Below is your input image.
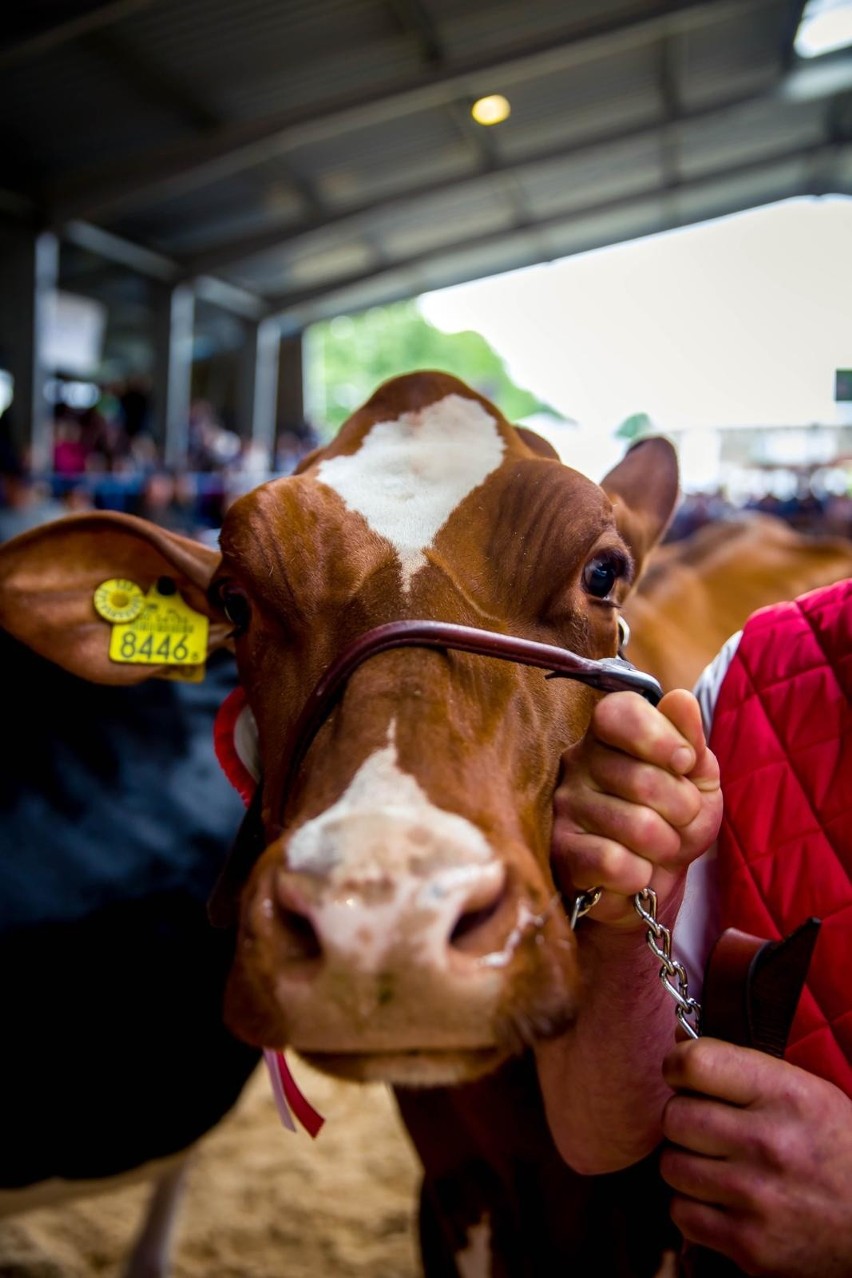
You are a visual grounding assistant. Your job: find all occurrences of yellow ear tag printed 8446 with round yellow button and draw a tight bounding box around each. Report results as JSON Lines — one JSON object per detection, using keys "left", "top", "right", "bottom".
{"left": 95, "top": 576, "right": 208, "bottom": 682}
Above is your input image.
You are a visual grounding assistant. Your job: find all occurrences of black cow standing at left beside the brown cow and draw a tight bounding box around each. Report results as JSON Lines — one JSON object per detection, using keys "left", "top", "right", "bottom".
{"left": 0, "top": 634, "right": 259, "bottom": 1278}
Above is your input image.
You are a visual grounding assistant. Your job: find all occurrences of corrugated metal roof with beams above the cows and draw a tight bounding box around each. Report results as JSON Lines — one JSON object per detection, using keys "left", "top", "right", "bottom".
{"left": 0, "top": 0, "right": 852, "bottom": 368}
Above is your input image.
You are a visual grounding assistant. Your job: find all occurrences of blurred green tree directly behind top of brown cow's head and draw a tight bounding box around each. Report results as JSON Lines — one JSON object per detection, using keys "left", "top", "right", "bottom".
{"left": 305, "top": 300, "right": 557, "bottom": 440}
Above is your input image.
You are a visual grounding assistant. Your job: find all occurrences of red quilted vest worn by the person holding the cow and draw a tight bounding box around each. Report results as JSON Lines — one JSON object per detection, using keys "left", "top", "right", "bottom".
{"left": 710, "top": 580, "right": 852, "bottom": 1095}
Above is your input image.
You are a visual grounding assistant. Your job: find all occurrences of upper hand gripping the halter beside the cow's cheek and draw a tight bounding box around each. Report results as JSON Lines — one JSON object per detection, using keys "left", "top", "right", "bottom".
{"left": 552, "top": 689, "right": 722, "bottom": 928}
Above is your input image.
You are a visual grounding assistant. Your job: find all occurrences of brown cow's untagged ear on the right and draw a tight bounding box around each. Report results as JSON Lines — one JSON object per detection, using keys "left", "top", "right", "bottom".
{"left": 600, "top": 436, "right": 678, "bottom": 571}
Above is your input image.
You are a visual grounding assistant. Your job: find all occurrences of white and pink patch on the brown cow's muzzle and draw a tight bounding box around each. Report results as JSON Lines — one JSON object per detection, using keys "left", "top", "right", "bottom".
{"left": 287, "top": 728, "right": 503, "bottom": 970}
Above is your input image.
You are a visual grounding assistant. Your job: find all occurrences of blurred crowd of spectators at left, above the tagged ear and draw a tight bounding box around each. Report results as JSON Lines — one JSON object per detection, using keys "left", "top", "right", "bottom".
{"left": 0, "top": 381, "right": 323, "bottom": 541}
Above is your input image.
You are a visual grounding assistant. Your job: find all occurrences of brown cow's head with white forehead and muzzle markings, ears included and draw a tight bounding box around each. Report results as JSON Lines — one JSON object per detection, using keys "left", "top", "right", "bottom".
{"left": 0, "top": 373, "right": 677, "bottom": 1084}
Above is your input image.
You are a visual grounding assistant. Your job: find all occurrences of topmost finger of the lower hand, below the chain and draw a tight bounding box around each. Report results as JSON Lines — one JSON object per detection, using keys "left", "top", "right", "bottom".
{"left": 663, "top": 1038, "right": 778, "bottom": 1108}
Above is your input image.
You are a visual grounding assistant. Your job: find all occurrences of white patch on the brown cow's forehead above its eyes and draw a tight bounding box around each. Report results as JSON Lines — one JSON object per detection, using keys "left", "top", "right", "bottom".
{"left": 317, "top": 395, "right": 506, "bottom": 590}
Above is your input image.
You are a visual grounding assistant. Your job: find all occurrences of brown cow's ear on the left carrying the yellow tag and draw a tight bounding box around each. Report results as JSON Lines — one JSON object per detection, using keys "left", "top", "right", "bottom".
{"left": 0, "top": 512, "right": 231, "bottom": 684}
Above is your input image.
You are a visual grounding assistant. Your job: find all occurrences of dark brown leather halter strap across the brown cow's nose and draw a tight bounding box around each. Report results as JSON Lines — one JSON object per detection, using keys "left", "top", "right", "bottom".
{"left": 208, "top": 620, "right": 663, "bottom": 927}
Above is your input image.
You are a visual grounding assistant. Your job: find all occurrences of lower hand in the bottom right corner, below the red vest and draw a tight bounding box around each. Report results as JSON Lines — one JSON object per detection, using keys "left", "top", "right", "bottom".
{"left": 660, "top": 1038, "right": 852, "bottom": 1278}
